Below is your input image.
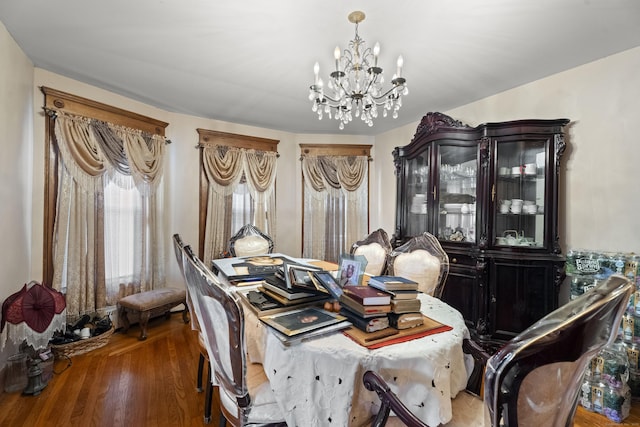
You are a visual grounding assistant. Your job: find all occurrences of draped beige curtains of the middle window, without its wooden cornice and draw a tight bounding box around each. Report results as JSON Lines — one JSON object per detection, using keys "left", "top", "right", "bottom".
{"left": 202, "top": 145, "right": 278, "bottom": 262}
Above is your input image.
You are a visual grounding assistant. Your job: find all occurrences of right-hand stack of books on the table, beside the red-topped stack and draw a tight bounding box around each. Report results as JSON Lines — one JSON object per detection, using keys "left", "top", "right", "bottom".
{"left": 369, "top": 276, "right": 423, "bottom": 329}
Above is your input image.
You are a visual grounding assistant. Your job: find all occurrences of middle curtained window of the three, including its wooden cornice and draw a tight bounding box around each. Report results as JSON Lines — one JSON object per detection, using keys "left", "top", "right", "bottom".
{"left": 198, "top": 129, "right": 278, "bottom": 260}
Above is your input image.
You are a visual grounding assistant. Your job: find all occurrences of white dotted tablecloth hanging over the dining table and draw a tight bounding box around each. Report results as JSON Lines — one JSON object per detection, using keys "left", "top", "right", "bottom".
{"left": 245, "top": 295, "right": 470, "bottom": 427}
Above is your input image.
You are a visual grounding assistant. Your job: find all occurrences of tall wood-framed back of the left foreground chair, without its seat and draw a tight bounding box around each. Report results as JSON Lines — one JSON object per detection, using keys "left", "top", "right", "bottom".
{"left": 184, "top": 246, "right": 251, "bottom": 424}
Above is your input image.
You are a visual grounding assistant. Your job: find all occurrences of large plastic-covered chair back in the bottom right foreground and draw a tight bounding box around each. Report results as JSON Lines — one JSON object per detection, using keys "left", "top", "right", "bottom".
{"left": 484, "top": 275, "right": 634, "bottom": 427}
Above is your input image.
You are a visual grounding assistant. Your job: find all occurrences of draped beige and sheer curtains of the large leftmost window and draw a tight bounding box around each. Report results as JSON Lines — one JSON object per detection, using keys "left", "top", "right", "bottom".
{"left": 52, "top": 111, "right": 166, "bottom": 318}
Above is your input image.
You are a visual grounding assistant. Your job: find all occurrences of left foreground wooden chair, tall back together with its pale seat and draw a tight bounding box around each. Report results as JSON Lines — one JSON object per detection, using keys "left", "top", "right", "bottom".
{"left": 179, "top": 248, "right": 285, "bottom": 426}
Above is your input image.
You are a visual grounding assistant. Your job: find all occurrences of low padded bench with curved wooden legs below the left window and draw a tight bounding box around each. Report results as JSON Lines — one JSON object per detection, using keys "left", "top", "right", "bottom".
{"left": 118, "top": 288, "right": 189, "bottom": 341}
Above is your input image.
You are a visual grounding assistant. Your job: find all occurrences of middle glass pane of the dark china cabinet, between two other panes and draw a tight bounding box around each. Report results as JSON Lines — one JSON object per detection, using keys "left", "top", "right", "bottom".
{"left": 436, "top": 143, "right": 478, "bottom": 243}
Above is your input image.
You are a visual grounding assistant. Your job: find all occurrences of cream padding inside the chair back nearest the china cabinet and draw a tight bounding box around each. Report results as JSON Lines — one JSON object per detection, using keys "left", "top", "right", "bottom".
{"left": 393, "top": 249, "right": 440, "bottom": 295}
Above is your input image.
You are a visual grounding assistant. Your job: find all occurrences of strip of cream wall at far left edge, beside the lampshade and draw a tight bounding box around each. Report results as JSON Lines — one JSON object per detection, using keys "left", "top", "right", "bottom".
{"left": 0, "top": 19, "right": 34, "bottom": 366}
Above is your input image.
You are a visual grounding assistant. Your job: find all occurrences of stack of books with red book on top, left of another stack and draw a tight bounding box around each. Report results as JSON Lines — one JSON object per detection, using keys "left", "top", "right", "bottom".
{"left": 339, "top": 285, "right": 391, "bottom": 332}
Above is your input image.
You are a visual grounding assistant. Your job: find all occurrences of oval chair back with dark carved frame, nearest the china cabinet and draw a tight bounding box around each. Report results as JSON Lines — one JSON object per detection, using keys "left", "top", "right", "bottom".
{"left": 388, "top": 232, "right": 449, "bottom": 298}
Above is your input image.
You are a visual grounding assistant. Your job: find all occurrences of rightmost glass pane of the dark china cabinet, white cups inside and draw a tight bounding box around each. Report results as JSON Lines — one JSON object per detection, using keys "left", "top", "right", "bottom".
{"left": 493, "top": 140, "right": 546, "bottom": 248}
